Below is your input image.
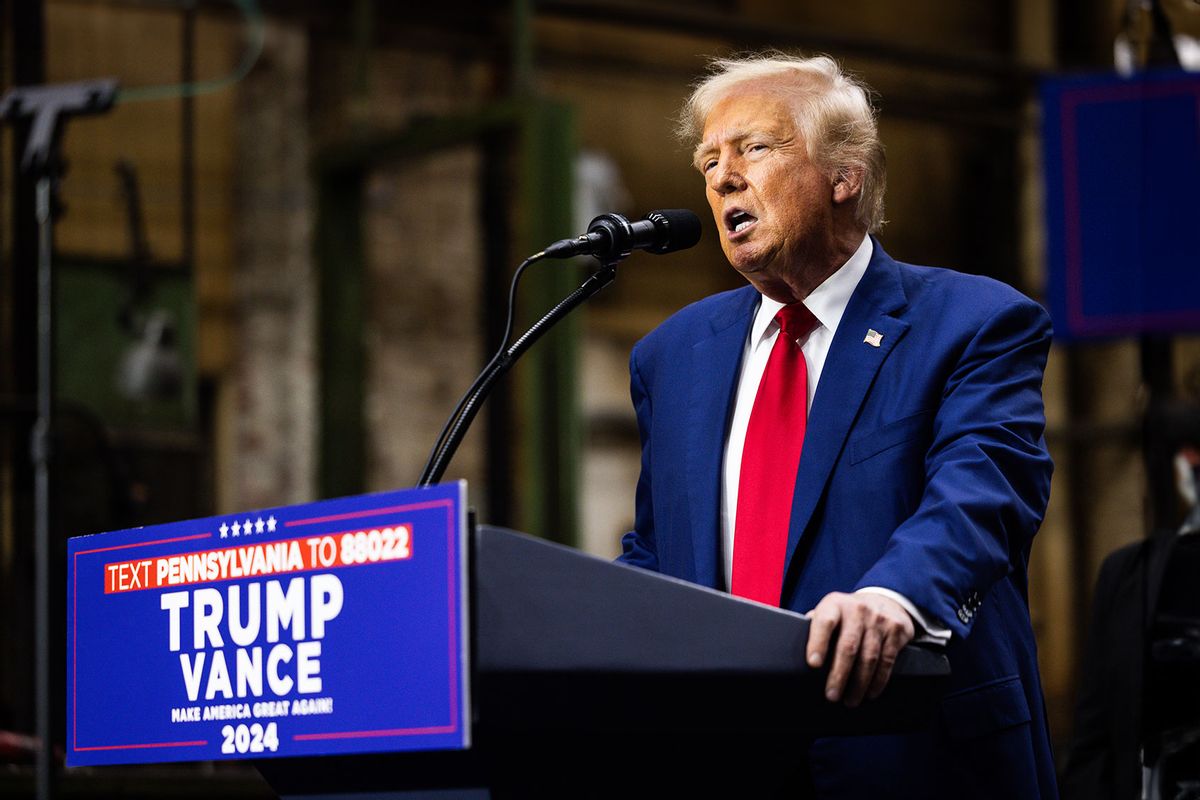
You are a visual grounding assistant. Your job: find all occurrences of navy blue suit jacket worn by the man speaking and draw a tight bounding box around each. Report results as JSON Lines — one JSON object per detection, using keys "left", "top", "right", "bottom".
{"left": 620, "top": 242, "right": 1056, "bottom": 798}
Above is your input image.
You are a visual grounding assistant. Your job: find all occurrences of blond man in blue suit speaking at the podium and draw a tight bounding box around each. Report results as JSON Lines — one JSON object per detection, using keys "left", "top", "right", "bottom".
{"left": 620, "top": 54, "right": 1056, "bottom": 799}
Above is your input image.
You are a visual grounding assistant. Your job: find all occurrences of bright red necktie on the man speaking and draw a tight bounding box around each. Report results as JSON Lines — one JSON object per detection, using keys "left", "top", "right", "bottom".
{"left": 731, "top": 302, "right": 817, "bottom": 606}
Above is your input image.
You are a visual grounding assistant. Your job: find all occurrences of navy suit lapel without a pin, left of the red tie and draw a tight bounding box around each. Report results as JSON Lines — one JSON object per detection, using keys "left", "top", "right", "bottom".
{"left": 686, "top": 287, "right": 758, "bottom": 588}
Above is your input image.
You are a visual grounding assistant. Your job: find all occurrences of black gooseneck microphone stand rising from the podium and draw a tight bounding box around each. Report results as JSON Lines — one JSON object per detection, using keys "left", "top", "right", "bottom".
{"left": 416, "top": 260, "right": 629, "bottom": 486}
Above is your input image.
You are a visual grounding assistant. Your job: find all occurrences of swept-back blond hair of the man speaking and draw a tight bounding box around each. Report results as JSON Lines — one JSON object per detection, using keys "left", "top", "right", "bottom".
{"left": 677, "top": 52, "right": 887, "bottom": 233}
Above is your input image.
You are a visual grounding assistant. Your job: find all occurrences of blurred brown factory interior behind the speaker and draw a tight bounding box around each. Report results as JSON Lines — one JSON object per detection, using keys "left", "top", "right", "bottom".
{"left": 0, "top": 0, "right": 1200, "bottom": 796}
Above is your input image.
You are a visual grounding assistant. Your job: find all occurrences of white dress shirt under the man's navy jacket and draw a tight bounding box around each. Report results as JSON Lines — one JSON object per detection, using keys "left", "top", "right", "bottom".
{"left": 721, "top": 236, "right": 950, "bottom": 642}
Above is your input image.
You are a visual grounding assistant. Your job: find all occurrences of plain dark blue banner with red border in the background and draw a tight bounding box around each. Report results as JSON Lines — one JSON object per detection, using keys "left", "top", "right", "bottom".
{"left": 1042, "top": 72, "right": 1200, "bottom": 338}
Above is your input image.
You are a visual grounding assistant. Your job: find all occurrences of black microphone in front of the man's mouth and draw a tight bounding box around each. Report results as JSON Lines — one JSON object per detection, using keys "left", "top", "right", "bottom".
{"left": 541, "top": 209, "right": 700, "bottom": 263}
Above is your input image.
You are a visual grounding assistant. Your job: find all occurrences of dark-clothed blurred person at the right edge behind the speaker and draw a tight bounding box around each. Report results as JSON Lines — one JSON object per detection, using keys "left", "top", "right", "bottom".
{"left": 1062, "top": 403, "right": 1200, "bottom": 800}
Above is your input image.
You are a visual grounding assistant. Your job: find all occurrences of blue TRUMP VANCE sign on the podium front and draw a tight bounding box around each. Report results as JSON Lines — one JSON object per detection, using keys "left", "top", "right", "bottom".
{"left": 67, "top": 481, "right": 470, "bottom": 766}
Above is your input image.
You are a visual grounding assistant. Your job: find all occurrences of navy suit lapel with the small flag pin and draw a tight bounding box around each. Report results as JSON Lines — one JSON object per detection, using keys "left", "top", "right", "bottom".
{"left": 784, "top": 241, "right": 910, "bottom": 584}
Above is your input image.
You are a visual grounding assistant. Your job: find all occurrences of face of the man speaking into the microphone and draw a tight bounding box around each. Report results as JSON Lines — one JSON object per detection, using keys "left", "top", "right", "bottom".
{"left": 695, "top": 85, "right": 840, "bottom": 302}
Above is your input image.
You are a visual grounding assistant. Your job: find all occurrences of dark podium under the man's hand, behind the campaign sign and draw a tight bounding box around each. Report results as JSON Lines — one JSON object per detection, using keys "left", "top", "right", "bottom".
{"left": 257, "top": 525, "right": 949, "bottom": 800}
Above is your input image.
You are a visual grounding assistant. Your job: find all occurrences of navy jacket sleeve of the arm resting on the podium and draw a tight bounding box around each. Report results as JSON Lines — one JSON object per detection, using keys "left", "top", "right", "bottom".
{"left": 857, "top": 297, "right": 1052, "bottom": 636}
